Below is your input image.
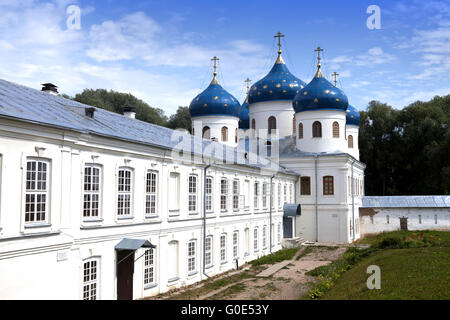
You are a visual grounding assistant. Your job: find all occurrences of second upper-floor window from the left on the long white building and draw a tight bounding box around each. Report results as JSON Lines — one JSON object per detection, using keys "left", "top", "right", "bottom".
{"left": 83, "top": 164, "right": 100, "bottom": 218}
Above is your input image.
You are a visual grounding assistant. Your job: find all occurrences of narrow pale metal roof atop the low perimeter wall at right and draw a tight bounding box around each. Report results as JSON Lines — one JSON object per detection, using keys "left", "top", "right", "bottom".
{"left": 362, "top": 196, "right": 450, "bottom": 208}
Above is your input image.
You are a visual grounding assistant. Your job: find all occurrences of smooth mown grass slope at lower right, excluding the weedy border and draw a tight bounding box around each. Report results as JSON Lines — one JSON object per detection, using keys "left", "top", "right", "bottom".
{"left": 322, "top": 247, "right": 450, "bottom": 300}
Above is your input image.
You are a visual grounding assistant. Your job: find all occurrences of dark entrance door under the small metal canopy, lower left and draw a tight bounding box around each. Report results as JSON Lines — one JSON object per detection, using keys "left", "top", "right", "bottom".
{"left": 116, "top": 250, "right": 134, "bottom": 300}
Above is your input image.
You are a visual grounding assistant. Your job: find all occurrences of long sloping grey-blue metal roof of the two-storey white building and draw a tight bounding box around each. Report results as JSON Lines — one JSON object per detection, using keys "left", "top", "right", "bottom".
{"left": 0, "top": 79, "right": 296, "bottom": 175}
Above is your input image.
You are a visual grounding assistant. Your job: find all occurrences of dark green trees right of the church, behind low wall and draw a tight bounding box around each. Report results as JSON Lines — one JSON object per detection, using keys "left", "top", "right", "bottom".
{"left": 359, "top": 95, "right": 450, "bottom": 195}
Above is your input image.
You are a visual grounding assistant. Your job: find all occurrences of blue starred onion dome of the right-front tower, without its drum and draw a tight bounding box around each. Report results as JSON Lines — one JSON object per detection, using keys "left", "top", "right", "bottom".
{"left": 292, "top": 67, "right": 348, "bottom": 112}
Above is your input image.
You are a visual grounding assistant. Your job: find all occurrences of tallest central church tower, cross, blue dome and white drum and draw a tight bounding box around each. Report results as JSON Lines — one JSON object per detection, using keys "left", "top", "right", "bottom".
{"left": 248, "top": 32, "right": 306, "bottom": 137}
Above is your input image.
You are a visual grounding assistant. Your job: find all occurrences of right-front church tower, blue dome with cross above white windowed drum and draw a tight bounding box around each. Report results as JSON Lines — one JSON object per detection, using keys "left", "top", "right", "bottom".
{"left": 292, "top": 47, "right": 348, "bottom": 153}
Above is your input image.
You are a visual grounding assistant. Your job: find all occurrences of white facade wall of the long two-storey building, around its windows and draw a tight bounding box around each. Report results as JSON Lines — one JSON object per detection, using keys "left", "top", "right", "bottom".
{"left": 0, "top": 120, "right": 296, "bottom": 299}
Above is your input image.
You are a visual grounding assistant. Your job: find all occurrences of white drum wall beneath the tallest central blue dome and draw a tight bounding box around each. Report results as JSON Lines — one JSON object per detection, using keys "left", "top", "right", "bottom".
{"left": 248, "top": 100, "right": 294, "bottom": 137}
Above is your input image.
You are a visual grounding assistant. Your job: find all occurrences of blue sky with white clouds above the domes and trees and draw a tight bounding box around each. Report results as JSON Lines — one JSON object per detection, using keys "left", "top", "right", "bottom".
{"left": 0, "top": 0, "right": 450, "bottom": 115}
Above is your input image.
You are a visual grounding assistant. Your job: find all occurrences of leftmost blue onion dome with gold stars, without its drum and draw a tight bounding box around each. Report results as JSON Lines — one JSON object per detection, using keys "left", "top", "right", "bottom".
{"left": 189, "top": 77, "right": 241, "bottom": 118}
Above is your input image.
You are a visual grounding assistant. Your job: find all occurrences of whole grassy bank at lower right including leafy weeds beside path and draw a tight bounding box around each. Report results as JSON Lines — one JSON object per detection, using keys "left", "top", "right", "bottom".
{"left": 303, "top": 231, "right": 450, "bottom": 300}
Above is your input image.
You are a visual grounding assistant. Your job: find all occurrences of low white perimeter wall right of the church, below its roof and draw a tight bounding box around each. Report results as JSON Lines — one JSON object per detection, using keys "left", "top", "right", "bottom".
{"left": 359, "top": 208, "right": 450, "bottom": 235}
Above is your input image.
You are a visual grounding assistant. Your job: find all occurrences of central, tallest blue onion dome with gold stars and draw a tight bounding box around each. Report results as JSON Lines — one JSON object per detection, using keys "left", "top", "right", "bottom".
{"left": 248, "top": 55, "right": 306, "bottom": 103}
